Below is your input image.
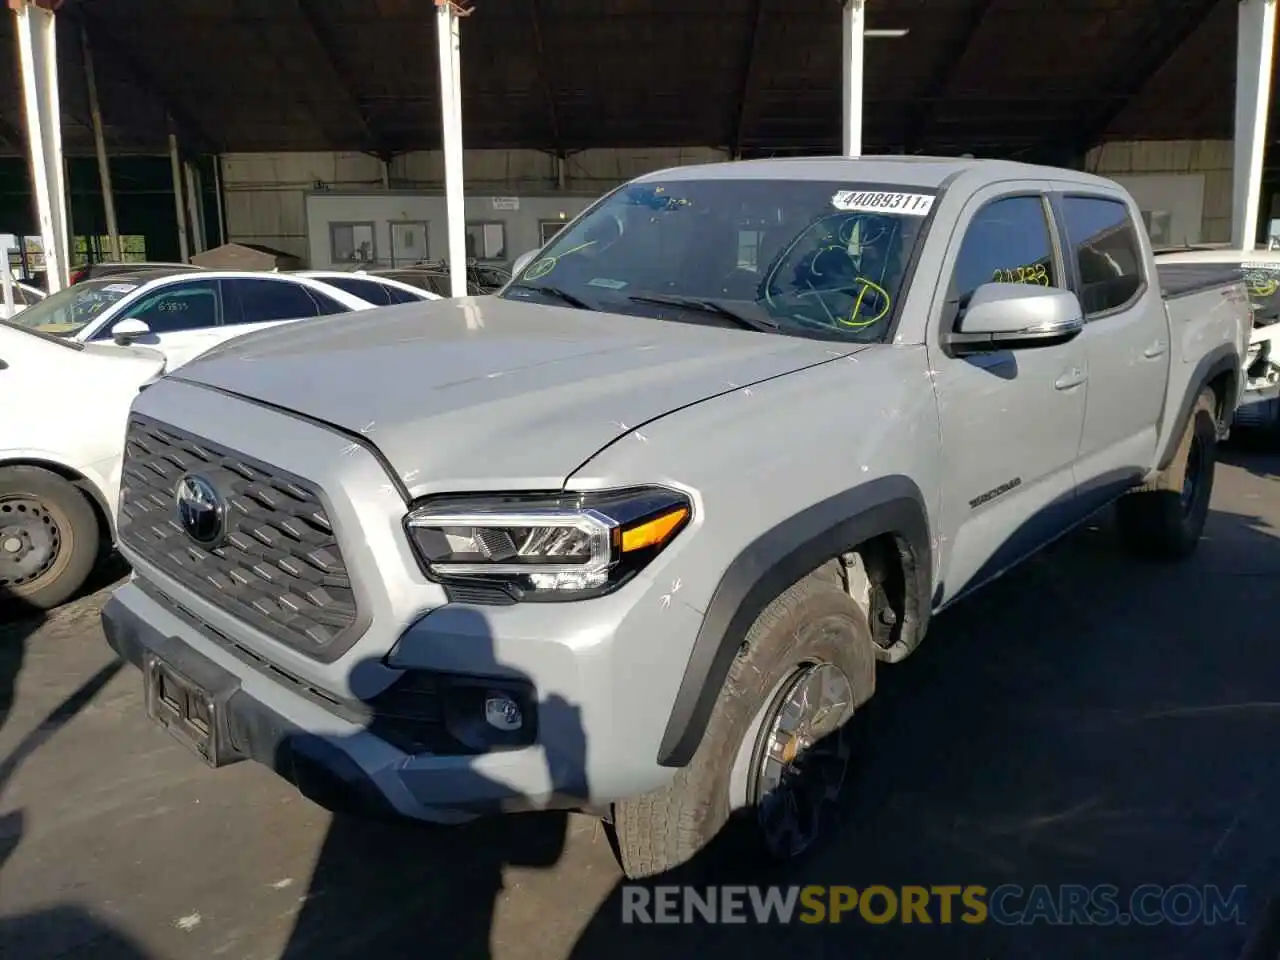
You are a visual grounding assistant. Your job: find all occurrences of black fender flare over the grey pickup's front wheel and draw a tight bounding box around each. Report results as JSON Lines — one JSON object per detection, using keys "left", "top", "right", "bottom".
{"left": 658, "top": 475, "right": 933, "bottom": 767}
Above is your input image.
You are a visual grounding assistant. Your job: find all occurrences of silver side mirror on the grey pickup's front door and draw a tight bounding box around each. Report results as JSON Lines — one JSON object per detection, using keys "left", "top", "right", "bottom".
{"left": 947, "top": 283, "right": 1084, "bottom": 351}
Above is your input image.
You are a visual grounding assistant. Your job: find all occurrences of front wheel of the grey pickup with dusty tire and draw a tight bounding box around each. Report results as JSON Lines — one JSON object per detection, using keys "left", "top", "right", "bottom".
{"left": 613, "top": 575, "right": 876, "bottom": 879}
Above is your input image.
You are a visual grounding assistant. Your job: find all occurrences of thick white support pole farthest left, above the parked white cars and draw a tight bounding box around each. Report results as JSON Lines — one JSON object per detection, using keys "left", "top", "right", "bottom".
{"left": 9, "top": 0, "right": 70, "bottom": 293}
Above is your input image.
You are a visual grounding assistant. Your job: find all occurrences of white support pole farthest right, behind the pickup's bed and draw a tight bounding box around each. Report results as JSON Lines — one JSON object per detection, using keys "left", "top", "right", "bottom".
{"left": 1231, "top": 0, "right": 1276, "bottom": 250}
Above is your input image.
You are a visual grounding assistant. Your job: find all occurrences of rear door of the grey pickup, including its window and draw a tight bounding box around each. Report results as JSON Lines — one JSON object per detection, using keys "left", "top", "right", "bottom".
{"left": 1053, "top": 186, "right": 1170, "bottom": 508}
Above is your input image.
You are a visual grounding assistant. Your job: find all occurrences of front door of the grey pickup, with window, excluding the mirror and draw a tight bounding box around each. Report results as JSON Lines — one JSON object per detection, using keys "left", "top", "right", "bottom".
{"left": 929, "top": 182, "right": 1088, "bottom": 603}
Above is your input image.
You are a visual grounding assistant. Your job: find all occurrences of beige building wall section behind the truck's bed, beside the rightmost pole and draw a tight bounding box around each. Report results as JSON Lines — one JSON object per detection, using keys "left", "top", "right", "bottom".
{"left": 1085, "top": 140, "right": 1233, "bottom": 243}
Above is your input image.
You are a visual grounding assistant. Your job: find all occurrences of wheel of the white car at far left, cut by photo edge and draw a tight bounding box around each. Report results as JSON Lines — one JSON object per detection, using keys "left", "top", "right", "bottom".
{"left": 0, "top": 467, "right": 101, "bottom": 609}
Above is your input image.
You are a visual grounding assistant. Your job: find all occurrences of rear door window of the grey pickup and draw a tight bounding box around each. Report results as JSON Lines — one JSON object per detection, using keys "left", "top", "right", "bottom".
{"left": 1062, "top": 197, "right": 1142, "bottom": 317}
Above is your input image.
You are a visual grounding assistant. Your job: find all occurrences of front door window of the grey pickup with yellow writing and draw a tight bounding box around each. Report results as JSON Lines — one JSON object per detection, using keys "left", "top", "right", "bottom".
{"left": 951, "top": 197, "right": 1061, "bottom": 307}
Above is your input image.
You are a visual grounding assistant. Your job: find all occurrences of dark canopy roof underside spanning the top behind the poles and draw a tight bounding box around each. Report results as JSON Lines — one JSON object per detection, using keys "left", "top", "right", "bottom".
{"left": 0, "top": 0, "right": 1236, "bottom": 155}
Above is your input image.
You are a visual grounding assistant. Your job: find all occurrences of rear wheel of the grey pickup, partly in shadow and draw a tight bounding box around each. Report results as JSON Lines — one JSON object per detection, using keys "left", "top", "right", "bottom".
{"left": 1116, "top": 390, "right": 1217, "bottom": 561}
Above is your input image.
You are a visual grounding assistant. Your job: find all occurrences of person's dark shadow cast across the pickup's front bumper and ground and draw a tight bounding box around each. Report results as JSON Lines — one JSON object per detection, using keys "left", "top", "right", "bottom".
{"left": 267, "top": 609, "right": 589, "bottom": 960}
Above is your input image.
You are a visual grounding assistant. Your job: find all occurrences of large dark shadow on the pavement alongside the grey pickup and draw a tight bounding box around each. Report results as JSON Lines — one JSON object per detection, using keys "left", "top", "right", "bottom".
{"left": 573, "top": 512, "right": 1280, "bottom": 960}
